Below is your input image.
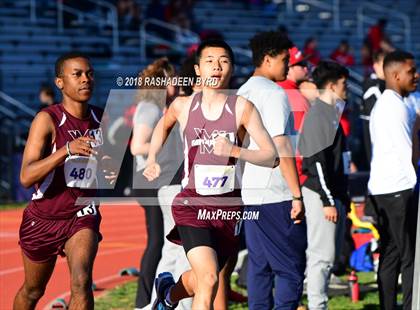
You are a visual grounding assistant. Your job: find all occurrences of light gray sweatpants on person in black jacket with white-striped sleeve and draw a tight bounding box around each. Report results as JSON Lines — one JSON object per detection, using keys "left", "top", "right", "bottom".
{"left": 302, "top": 187, "right": 346, "bottom": 310}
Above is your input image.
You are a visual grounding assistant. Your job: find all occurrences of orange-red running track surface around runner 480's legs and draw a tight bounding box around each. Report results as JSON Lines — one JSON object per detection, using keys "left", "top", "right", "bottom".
{"left": 0, "top": 202, "right": 147, "bottom": 310}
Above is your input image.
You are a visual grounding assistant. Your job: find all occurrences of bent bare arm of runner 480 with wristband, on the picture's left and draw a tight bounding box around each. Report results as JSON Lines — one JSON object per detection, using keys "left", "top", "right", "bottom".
{"left": 20, "top": 112, "right": 95, "bottom": 188}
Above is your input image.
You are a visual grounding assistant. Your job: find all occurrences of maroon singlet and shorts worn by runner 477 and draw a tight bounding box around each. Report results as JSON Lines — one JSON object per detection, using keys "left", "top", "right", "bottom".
{"left": 168, "top": 92, "right": 243, "bottom": 236}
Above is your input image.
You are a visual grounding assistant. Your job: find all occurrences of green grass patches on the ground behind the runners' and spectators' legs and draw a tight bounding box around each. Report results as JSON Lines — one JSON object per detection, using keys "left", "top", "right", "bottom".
{"left": 95, "top": 272, "right": 401, "bottom": 310}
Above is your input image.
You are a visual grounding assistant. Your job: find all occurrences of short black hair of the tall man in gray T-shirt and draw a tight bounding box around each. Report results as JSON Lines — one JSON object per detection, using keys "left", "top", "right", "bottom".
{"left": 249, "top": 31, "right": 293, "bottom": 67}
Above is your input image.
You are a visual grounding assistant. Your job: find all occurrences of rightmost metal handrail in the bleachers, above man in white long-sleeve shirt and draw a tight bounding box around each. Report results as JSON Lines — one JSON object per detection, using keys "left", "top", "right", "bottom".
{"left": 357, "top": 2, "right": 411, "bottom": 50}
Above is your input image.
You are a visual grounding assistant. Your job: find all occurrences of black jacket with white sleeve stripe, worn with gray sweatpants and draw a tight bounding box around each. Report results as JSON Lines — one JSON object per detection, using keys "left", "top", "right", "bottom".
{"left": 298, "top": 99, "right": 350, "bottom": 206}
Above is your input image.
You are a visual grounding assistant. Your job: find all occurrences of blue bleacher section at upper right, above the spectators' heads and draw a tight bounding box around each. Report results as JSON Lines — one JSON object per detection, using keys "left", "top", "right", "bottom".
{"left": 194, "top": 0, "right": 420, "bottom": 71}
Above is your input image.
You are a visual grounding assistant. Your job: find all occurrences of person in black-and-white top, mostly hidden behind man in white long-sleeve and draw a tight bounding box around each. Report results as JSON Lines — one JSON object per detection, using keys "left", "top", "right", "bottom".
{"left": 360, "top": 50, "right": 386, "bottom": 167}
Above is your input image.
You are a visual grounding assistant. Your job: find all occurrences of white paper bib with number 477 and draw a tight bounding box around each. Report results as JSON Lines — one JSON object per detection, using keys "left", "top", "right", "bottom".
{"left": 194, "top": 165, "right": 235, "bottom": 196}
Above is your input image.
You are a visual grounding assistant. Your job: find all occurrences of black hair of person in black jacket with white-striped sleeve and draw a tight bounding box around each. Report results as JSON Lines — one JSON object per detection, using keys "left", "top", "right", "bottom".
{"left": 312, "top": 61, "right": 349, "bottom": 89}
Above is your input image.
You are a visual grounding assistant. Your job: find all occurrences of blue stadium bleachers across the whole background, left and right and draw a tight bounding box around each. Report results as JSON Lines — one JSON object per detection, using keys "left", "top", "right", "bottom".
{"left": 0, "top": 0, "right": 420, "bottom": 198}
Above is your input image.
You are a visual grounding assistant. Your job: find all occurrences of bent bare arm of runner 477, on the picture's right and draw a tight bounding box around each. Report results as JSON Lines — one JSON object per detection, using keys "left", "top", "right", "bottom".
{"left": 215, "top": 97, "right": 279, "bottom": 168}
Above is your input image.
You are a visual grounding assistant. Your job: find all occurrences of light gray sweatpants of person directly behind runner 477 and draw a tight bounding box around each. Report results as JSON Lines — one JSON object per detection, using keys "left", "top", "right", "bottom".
{"left": 143, "top": 185, "right": 192, "bottom": 310}
